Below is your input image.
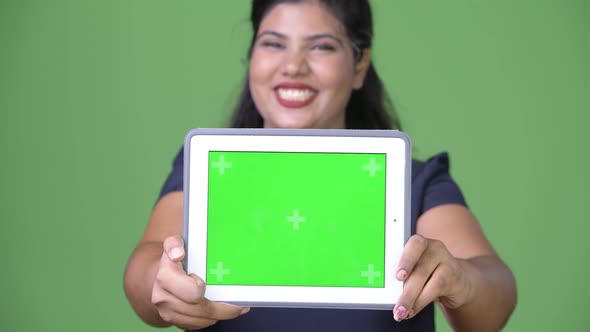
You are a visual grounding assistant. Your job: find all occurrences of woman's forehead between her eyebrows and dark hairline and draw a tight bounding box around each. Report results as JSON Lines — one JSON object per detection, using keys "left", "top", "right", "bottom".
{"left": 257, "top": 1, "right": 346, "bottom": 36}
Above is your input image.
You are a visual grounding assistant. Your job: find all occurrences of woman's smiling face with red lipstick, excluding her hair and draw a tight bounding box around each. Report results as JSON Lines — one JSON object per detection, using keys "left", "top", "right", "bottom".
{"left": 249, "top": 3, "right": 370, "bottom": 128}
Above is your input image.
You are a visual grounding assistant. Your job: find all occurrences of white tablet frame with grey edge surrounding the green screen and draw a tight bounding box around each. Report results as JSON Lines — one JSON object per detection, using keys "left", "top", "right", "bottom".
{"left": 183, "top": 129, "right": 411, "bottom": 309}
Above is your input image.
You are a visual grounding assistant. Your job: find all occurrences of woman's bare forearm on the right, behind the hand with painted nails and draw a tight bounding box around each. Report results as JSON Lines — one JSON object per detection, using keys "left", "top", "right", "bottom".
{"left": 441, "top": 256, "right": 516, "bottom": 331}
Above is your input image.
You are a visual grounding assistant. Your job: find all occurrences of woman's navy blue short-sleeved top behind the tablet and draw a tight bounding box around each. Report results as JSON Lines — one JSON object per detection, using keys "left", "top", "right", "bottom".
{"left": 160, "top": 149, "right": 466, "bottom": 332}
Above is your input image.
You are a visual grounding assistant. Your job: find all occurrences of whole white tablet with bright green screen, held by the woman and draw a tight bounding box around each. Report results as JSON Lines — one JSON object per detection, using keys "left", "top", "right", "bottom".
{"left": 184, "top": 129, "right": 411, "bottom": 309}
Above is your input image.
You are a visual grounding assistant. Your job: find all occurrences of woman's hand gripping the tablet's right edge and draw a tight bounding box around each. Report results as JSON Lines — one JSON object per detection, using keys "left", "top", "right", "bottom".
{"left": 393, "top": 235, "right": 471, "bottom": 322}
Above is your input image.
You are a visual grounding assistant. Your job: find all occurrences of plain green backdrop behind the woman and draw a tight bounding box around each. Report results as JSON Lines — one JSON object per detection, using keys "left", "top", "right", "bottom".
{"left": 0, "top": 0, "right": 590, "bottom": 331}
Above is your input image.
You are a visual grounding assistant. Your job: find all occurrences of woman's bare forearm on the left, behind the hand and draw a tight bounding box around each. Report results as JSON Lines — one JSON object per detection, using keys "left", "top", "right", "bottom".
{"left": 124, "top": 241, "right": 170, "bottom": 327}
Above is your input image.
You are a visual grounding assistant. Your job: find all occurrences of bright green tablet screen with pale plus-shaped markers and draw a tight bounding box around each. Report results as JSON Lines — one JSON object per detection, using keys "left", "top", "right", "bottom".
{"left": 206, "top": 151, "right": 386, "bottom": 287}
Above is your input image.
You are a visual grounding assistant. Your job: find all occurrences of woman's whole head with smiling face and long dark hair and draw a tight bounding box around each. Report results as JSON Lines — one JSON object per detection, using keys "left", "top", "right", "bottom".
{"left": 231, "top": 0, "right": 400, "bottom": 129}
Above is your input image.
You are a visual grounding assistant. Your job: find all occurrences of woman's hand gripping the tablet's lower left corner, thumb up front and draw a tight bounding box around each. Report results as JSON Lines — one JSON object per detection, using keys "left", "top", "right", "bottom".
{"left": 152, "top": 236, "right": 250, "bottom": 330}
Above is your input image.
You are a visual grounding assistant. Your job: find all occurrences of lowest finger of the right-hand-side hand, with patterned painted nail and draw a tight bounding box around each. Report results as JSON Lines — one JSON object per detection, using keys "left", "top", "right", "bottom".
{"left": 393, "top": 257, "right": 438, "bottom": 322}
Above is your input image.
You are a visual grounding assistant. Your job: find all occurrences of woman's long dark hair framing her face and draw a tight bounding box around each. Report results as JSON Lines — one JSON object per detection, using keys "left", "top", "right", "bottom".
{"left": 230, "top": 0, "right": 401, "bottom": 129}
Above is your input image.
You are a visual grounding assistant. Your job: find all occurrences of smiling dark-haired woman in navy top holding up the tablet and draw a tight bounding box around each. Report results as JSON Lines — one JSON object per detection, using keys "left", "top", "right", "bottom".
{"left": 125, "top": 0, "right": 516, "bottom": 331}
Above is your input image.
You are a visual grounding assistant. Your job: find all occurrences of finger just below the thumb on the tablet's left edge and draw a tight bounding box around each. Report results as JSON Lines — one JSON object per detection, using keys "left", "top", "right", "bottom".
{"left": 152, "top": 260, "right": 205, "bottom": 303}
